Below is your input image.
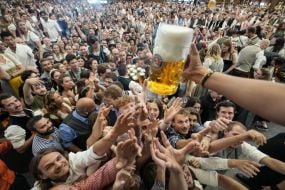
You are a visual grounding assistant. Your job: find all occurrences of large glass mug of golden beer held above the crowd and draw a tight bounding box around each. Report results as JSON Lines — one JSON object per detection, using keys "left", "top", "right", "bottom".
{"left": 148, "top": 23, "right": 193, "bottom": 95}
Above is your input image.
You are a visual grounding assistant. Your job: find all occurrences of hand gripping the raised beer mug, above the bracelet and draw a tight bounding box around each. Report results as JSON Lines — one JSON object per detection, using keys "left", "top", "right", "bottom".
{"left": 182, "top": 43, "right": 208, "bottom": 83}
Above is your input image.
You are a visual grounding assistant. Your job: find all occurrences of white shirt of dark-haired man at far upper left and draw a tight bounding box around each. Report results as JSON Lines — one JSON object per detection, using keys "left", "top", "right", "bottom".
{"left": 5, "top": 44, "right": 37, "bottom": 68}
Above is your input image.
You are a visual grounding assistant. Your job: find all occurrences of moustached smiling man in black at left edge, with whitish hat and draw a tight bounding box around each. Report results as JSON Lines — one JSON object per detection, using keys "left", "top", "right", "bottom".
{"left": 0, "top": 93, "right": 34, "bottom": 173}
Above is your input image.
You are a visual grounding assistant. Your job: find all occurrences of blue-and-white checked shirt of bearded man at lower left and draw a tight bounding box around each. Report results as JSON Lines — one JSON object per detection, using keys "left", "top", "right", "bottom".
{"left": 32, "top": 128, "right": 63, "bottom": 156}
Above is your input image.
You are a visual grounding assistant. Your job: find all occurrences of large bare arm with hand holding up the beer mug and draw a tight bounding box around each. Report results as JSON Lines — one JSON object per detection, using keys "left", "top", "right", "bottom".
{"left": 183, "top": 44, "right": 285, "bottom": 124}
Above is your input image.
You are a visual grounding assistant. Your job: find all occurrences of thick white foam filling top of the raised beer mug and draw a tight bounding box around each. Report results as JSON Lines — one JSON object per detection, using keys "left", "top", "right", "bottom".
{"left": 153, "top": 23, "right": 193, "bottom": 61}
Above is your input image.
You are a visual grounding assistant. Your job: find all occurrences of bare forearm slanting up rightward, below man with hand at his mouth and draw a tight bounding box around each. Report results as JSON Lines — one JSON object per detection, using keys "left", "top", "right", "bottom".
{"left": 206, "top": 134, "right": 247, "bottom": 153}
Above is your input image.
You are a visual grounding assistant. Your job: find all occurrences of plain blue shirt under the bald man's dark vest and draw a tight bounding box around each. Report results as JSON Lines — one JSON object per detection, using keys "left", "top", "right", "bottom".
{"left": 59, "top": 110, "right": 89, "bottom": 148}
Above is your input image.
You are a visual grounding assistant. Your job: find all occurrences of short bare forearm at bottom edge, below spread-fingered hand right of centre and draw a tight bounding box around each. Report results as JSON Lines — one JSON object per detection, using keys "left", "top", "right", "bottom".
{"left": 169, "top": 168, "right": 188, "bottom": 190}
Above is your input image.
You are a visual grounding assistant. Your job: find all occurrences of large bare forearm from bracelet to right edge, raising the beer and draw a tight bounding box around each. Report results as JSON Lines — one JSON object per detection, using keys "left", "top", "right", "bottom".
{"left": 205, "top": 73, "right": 285, "bottom": 124}
